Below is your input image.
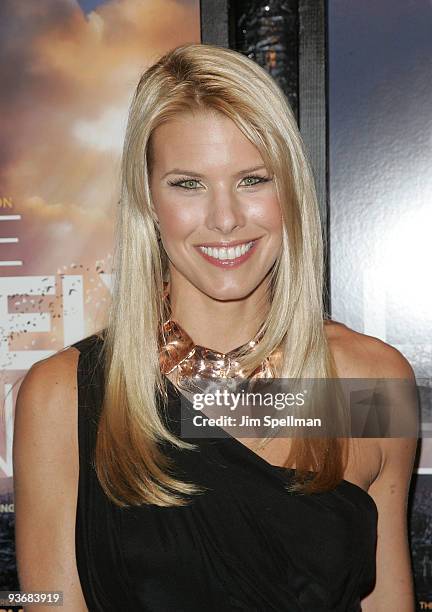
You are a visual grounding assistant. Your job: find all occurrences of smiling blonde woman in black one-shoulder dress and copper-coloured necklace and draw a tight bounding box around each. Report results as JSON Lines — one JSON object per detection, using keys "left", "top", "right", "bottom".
{"left": 14, "top": 44, "right": 416, "bottom": 612}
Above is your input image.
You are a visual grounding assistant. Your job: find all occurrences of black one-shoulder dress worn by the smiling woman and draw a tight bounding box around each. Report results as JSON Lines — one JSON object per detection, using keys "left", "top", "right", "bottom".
{"left": 73, "top": 335, "right": 378, "bottom": 612}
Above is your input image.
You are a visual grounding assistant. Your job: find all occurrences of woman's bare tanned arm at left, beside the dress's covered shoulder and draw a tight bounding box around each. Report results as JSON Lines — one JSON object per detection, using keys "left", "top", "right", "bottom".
{"left": 13, "top": 348, "right": 87, "bottom": 612}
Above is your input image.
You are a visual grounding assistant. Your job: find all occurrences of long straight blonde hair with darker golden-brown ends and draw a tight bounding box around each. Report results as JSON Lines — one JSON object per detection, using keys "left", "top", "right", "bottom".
{"left": 95, "top": 44, "right": 344, "bottom": 506}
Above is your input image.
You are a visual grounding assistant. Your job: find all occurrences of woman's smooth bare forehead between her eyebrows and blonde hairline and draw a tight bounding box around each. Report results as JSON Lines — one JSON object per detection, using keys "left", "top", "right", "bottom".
{"left": 151, "top": 111, "right": 262, "bottom": 171}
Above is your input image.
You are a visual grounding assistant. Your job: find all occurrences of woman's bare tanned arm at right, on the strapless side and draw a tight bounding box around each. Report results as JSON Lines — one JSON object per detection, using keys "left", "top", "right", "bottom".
{"left": 362, "top": 343, "right": 417, "bottom": 612}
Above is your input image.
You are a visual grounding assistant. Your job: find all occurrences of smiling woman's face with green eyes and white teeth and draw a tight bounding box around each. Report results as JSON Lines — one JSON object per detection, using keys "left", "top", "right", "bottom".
{"left": 150, "top": 112, "right": 282, "bottom": 300}
